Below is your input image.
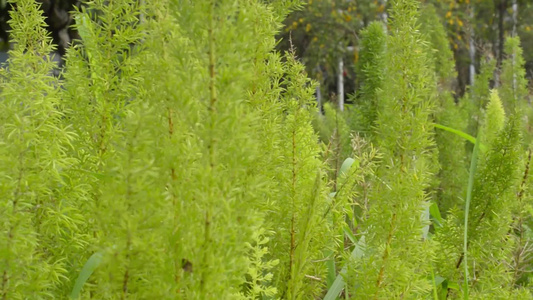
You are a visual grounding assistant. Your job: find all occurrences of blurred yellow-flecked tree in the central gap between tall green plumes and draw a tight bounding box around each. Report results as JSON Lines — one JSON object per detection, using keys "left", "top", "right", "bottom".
{"left": 278, "top": 0, "right": 378, "bottom": 103}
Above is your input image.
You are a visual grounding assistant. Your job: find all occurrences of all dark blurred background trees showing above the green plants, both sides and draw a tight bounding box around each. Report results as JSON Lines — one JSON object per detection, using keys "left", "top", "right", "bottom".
{"left": 0, "top": 0, "right": 533, "bottom": 106}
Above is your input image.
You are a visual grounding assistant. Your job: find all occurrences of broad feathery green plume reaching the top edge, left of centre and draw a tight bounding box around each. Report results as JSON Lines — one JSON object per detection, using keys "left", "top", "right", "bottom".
{"left": 134, "top": 1, "right": 290, "bottom": 299}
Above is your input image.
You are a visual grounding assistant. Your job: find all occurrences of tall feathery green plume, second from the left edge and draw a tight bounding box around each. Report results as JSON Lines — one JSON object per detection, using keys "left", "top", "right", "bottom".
{"left": 64, "top": 1, "right": 159, "bottom": 298}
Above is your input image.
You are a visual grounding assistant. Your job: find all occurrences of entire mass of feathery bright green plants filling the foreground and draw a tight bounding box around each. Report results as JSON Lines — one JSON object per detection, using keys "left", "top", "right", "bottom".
{"left": 0, "top": 0, "right": 533, "bottom": 300}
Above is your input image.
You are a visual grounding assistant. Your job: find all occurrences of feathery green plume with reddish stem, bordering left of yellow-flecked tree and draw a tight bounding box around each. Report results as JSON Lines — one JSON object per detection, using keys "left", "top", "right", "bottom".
{"left": 231, "top": 3, "right": 330, "bottom": 299}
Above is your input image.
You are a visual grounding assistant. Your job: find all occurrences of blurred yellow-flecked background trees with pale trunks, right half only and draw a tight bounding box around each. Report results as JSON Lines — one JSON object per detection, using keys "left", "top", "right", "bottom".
{"left": 278, "top": 0, "right": 533, "bottom": 106}
